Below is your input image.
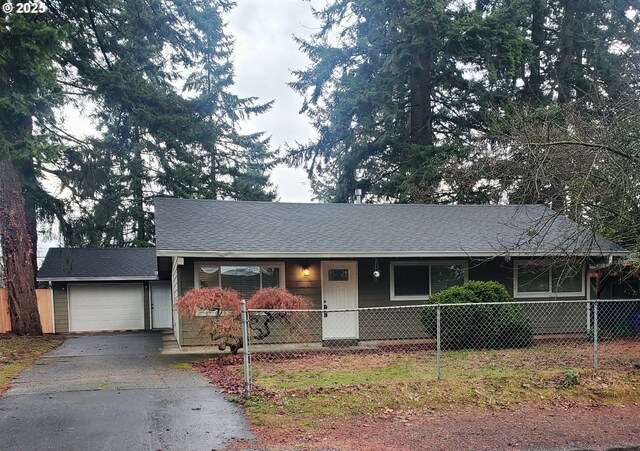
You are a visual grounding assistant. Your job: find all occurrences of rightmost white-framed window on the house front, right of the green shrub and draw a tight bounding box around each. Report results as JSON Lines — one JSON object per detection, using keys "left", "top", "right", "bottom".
{"left": 514, "top": 262, "right": 585, "bottom": 297}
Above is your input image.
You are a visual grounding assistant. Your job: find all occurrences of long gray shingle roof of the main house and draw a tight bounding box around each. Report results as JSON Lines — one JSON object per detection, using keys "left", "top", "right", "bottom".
{"left": 155, "top": 198, "right": 624, "bottom": 257}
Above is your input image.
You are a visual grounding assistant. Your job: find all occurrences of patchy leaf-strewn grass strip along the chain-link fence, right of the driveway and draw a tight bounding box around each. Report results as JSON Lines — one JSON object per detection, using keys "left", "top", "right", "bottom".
{"left": 198, "top": 341, "right": 640, "bottom": 428}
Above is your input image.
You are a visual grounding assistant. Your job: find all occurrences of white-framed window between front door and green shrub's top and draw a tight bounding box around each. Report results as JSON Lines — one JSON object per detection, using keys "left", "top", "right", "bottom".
{"left": 390, "top": 261, "right": 467, "bottom": 301}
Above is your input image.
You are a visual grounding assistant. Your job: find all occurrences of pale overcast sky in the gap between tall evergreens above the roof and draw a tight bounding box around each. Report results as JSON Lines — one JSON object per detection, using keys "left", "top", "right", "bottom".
{"left": 227, "top": 0, "right": 324, "bottom": 202}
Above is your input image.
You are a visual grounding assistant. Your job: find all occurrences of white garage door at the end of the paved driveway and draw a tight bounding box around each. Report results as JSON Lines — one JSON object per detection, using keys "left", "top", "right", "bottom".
{"left": 69, "top": 283, "right": 144, "bottom": 332}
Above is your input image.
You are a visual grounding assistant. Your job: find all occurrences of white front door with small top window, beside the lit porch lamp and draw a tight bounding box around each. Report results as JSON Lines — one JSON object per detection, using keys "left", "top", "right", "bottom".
{"left": 321, "top": 261, "right": 358, "bottom": 340}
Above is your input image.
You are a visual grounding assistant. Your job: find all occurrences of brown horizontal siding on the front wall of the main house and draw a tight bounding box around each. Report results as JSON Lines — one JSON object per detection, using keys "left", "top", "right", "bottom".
{"left": 174, "top": 258, "right": 587, "bottom": 346}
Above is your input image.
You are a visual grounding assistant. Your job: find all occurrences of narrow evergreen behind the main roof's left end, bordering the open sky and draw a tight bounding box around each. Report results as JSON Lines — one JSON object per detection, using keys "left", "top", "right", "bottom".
{"left": 184, "top": 4, "right": 275, "bottom": 200}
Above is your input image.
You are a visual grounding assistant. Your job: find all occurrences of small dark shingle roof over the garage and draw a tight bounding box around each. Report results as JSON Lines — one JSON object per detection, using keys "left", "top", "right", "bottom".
{"left": 38, "top": 247, "right": 158, "bottom": 280}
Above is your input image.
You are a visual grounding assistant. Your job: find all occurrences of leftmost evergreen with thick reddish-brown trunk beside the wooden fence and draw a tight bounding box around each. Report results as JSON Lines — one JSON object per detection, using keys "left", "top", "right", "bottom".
{"left": 0, "top": 13, "right": 63, "bottom": 334}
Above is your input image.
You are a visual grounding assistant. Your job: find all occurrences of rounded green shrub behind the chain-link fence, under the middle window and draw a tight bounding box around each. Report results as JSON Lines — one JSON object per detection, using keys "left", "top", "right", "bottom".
{"left": 421, "top": 281, "right": 533, "bottom": 349}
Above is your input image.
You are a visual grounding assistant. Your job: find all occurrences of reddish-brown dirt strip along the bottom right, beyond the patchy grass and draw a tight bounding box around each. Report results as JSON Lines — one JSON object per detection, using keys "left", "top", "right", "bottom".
{"left": 231, "top": 405, "right": 640, "bottom": 451}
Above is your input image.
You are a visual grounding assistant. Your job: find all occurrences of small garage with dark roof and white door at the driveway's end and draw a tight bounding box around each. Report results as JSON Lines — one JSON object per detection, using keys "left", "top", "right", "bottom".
{"left": 38, "top": 248, "right": 172, "bottom": 333}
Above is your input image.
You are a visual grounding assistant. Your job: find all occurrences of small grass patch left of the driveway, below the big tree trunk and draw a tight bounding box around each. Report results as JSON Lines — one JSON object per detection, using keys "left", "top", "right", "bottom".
{"left": 0, "top": 334, "right": 64, "bottom": 396}
